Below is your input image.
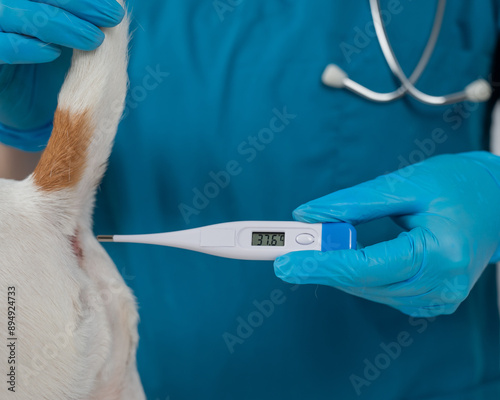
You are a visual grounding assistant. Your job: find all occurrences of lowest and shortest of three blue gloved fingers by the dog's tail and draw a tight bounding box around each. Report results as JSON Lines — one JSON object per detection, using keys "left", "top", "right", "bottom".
{"left": 0, "top": 32, "right": 61, "bottom": 64}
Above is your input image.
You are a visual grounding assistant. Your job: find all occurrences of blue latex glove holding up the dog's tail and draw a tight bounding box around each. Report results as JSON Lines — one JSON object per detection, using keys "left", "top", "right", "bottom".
{"left": 0, "top": 0, "right": 124, "bottom": 151}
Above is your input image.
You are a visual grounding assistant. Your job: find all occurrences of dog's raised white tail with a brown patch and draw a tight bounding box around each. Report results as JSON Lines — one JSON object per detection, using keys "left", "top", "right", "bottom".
{"left": 33, "top": 0, "right": 129, "bottom": 227}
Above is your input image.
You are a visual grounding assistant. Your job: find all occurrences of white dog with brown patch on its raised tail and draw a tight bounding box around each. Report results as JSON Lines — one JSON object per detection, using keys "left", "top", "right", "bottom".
{"left": 0, "top": 1, "right": 145, "bottom": 400}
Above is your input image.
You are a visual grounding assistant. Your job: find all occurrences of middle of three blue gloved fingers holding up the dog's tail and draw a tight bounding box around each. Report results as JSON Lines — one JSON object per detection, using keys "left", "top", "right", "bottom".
{"left": 0, "top": 0, "right": 104, "bottom": 51}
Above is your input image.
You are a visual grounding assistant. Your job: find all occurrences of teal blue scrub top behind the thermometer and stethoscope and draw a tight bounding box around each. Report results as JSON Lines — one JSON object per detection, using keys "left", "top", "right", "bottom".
{"left": 95, "top": 0, "right": 500, "bottom": 400}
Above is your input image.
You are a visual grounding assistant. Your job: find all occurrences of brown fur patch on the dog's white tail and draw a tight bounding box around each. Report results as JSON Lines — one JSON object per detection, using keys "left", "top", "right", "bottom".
{"left": 33, "top": 109, "right": 94, "bottom": 191}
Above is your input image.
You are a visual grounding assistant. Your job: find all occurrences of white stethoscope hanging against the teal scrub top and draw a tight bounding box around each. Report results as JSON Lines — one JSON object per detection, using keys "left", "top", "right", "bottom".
{"left": 322, "top": 0, "right": 492, "bottom": 106}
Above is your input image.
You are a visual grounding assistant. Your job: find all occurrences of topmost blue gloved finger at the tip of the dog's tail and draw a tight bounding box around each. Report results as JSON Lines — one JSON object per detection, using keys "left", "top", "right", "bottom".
{"left": 31, "top": 0, "right": 125, "bottom": 28}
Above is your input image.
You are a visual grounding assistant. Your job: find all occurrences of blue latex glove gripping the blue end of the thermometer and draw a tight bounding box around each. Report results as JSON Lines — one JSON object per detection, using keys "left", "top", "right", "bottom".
{"left": 274, "top": 152, "right": 500, "bottom": 317}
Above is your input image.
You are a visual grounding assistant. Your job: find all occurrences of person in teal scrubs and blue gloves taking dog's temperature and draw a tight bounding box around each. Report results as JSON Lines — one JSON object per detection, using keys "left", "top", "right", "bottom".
{"left": 0, "top": 0, "right": 500, "bottom": 400}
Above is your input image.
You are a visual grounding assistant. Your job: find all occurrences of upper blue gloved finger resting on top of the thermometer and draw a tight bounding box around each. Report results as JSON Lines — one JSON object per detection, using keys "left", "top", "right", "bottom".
{"left": 293, "top": 174, "right": 420, "bottom": 225}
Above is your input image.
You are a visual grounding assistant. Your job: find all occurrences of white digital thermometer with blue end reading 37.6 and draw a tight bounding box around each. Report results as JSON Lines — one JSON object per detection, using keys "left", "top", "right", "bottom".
{"left": 97, "top": 221, "right": 356, "bottom": 260}
